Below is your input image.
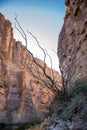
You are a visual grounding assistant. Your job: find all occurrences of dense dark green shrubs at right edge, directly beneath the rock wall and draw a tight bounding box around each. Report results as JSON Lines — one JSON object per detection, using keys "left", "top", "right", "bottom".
{"left": 59, "top": 79, "right": 87, "bottom": 120}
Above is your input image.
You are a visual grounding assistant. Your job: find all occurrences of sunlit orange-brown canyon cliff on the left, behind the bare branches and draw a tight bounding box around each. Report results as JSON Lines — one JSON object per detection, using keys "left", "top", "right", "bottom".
{"left": 0, "top": 14, "right": 59, "bottom": 124}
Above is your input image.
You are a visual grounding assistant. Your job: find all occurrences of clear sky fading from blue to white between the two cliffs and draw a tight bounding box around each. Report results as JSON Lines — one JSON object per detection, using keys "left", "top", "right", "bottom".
{"left": 0, "top": 0, "right": 65, "bottom": 70}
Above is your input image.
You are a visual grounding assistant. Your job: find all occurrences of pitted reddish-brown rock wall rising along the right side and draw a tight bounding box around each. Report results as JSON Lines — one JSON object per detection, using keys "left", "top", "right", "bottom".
{"left": 58, "top": 0, "right": 87, "bottom": 89}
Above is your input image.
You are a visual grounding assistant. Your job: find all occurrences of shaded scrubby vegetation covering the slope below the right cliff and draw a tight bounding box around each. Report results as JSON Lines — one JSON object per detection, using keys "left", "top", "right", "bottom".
{"left": 14, "top": 79, "right": 87, "bottom": 130}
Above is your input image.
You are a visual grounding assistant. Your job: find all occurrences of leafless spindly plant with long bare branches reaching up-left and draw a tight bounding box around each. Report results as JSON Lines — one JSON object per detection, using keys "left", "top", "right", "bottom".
{"left": 15, "top": 15, "right": 68, "bottom": 98}
